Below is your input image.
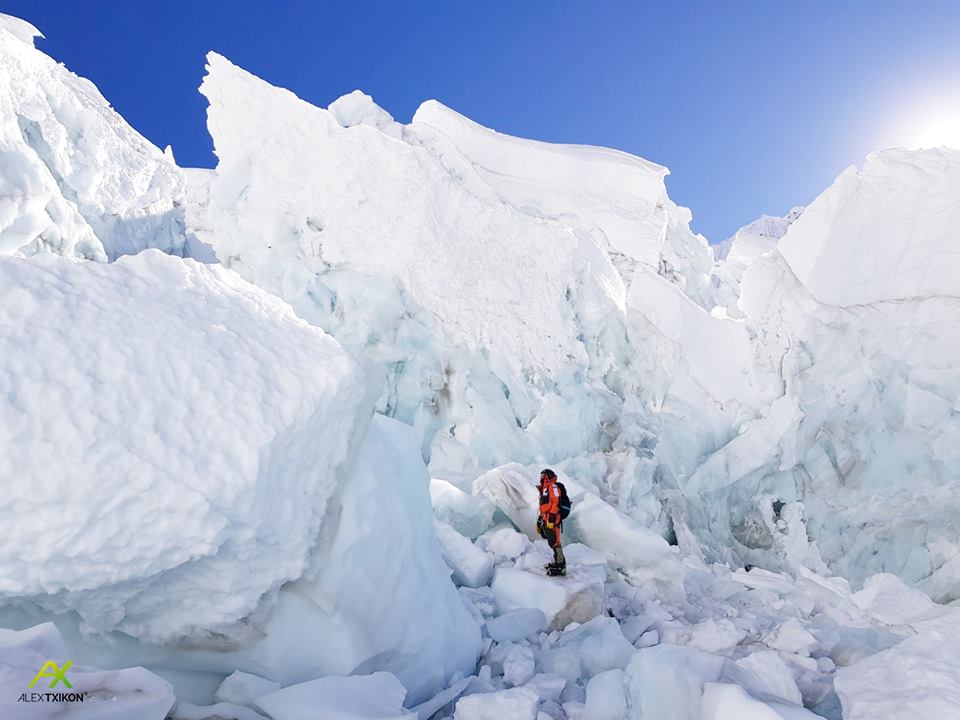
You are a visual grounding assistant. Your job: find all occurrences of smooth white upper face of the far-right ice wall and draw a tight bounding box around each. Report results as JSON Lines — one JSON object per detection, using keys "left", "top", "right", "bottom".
{"left": 778, "top": 148, "right": 960, "bottom": 307}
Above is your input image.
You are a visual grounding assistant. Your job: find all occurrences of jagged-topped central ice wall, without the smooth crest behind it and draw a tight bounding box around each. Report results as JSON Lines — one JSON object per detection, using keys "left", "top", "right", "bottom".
{"left": 192, "top": 54, "right": 648, "bottom": 480}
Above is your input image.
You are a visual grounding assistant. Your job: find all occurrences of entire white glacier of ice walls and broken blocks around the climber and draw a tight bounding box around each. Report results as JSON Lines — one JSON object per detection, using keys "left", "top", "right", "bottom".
{"left": 0, "top": 15, "right": 960, "bottom": 720}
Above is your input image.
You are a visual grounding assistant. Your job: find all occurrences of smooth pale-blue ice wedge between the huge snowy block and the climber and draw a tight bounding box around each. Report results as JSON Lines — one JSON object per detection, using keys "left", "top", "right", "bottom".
{"left": 219, "top": 415, "right": 480, "bottom": 703}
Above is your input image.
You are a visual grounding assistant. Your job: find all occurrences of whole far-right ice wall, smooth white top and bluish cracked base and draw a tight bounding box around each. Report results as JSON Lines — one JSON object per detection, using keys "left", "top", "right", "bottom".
{"left": 688, "top": 149, "right": 960, "bottom": 600}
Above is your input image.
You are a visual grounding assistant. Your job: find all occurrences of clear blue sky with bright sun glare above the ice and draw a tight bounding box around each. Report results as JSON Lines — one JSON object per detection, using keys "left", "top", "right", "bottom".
{"left": 9, "top": 0, "right": 960, "bottom": 242}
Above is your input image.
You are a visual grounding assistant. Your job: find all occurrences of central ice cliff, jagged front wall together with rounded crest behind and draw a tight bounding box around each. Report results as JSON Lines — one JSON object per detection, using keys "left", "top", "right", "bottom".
{"left": 197, "top": 54, "right": 736, "bottom": 500}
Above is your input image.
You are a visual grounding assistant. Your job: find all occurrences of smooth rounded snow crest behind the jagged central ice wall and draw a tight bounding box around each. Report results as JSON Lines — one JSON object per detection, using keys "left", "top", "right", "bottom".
{"left": 408, "top": 100, "right": 709, "bottom": 299}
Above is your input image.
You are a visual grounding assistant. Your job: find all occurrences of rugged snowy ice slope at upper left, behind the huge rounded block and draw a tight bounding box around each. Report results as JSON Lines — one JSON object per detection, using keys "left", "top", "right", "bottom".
{"left": 0, "top": 16, "right": 186, "bottom": 259}
